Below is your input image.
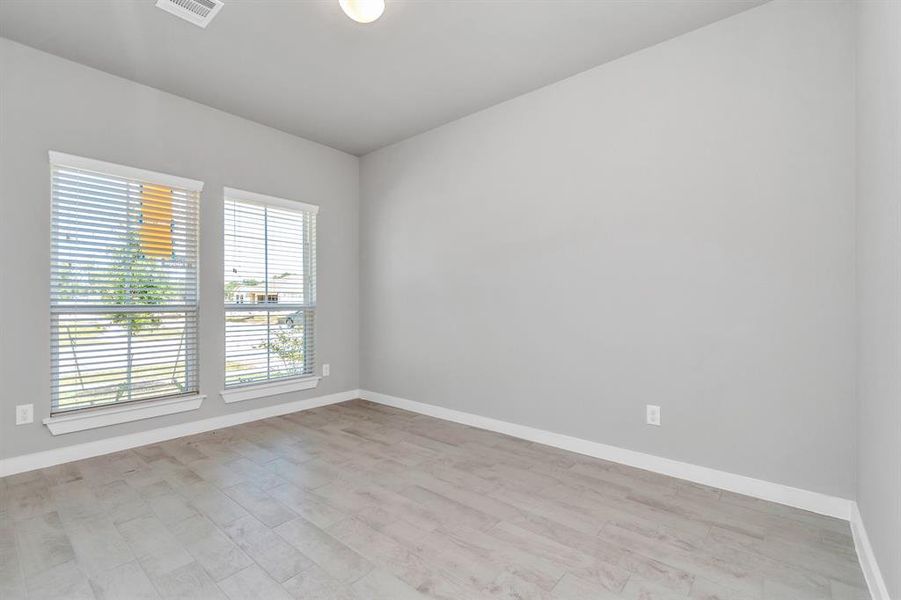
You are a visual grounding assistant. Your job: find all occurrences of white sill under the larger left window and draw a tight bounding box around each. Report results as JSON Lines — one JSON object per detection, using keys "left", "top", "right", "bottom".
{"left": 44, "top": 394, "right": 206, "bottom": 435}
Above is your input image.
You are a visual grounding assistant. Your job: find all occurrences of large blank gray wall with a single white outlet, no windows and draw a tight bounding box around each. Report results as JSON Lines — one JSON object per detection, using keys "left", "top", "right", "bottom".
{"left": 361, "top": 1, "right": 857, "bottom": 498}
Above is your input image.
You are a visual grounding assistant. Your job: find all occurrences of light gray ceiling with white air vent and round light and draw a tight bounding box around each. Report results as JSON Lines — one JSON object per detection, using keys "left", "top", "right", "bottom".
{"left": 0, "top": 0, "right": 766, "bottom": 155}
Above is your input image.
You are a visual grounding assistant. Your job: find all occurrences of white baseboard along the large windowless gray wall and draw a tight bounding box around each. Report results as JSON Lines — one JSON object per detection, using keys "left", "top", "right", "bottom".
{"left": 360, "top": 390, "right": 854, "bottom": 521}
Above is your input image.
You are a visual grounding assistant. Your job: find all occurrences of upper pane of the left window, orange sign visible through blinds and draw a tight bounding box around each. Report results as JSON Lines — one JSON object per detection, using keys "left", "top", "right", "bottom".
{"left": 51, "top": 168, "right": 197, "bottom": 305}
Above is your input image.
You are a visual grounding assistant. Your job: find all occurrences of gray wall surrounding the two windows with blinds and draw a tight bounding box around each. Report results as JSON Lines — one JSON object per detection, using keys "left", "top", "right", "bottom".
{"left": 0, "top": 39, "right": 359, "bottom": 458}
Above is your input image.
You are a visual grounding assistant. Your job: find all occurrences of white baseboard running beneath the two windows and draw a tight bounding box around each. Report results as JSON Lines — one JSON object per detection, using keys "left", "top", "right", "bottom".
{"left": 0, "top": 390, "right": 361, "bottom": 477}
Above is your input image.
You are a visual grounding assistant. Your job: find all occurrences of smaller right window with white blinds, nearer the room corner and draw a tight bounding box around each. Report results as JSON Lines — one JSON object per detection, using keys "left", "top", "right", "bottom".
{"left": 225, "top": 188, "right": 318, "bottom": 388}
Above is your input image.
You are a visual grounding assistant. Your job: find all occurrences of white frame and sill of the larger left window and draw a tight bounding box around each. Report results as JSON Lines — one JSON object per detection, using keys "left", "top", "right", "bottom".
{"left": 43, "top": 151, "right": 205, "bottom": 435}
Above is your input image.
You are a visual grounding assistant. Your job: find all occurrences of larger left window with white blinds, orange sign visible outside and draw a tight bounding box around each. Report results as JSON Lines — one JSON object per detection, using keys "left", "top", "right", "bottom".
{"left": 50, "top": 152, "right": 202, "bottom": 413}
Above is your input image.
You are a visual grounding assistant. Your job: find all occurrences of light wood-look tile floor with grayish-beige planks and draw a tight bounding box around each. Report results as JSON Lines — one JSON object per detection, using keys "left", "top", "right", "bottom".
{"left": 0, "top": 400, "right": 868, "bottom": 600}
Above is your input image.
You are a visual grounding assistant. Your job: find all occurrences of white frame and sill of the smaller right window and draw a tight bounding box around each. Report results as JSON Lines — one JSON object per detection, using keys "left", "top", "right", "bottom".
{"left": 220, "top": 187, "right": 321, "bottom": 403}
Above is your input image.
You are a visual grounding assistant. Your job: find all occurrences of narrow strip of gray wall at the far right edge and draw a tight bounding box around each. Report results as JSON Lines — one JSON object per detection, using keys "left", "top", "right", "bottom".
{"left": 857, "top": 0, "right": 901, "bottom": 598}
